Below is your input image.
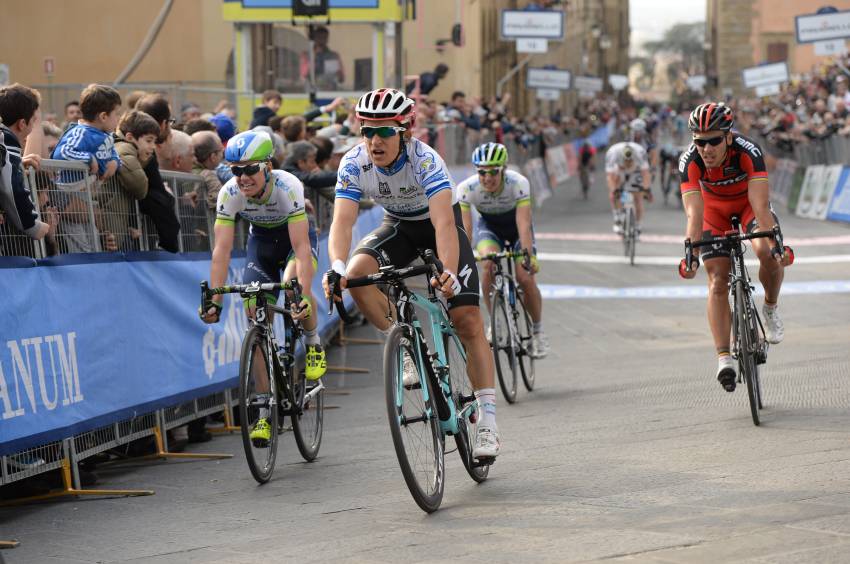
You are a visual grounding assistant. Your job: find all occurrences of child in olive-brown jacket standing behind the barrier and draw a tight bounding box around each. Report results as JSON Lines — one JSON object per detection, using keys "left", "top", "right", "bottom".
{"left": 98, "top": 110, "right": 160, "bottom": 251}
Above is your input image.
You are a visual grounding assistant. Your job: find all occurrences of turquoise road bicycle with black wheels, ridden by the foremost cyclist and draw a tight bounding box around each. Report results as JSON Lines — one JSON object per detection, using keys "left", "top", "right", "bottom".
{"left": 328, "top": 250, "right": 495, "bottom": 513}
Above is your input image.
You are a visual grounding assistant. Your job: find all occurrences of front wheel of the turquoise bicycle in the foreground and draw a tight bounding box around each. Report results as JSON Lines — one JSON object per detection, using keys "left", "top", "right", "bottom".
{"left": 384, "top": 326, "right": 445, "bottom": 513}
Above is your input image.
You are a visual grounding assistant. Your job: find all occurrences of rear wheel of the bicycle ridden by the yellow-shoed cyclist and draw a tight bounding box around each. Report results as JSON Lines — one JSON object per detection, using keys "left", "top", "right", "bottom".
{"left": 289, "top": 338, "right": 325, "bottom": 462}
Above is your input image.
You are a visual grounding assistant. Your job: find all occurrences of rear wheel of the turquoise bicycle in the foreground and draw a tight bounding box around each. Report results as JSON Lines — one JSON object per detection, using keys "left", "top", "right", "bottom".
{"left": 443, "top": 335, "right": 490, "bottom": 484}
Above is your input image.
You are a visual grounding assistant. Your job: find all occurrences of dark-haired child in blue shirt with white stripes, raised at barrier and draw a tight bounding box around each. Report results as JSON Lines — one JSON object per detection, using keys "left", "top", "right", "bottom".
{"left": 53, "top": 84, "right": 121, "bottom": 253}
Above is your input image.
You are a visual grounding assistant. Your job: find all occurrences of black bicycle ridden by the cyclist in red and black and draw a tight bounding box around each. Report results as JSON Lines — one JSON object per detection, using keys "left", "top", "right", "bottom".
{"left": 679, "top": 216, "right": 794, "bottom": 425}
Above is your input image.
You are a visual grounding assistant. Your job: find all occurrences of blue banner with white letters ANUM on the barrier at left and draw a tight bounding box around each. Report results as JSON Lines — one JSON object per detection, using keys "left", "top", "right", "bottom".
{"left": 0, "top": 208, "right": 383, "bottom": 454}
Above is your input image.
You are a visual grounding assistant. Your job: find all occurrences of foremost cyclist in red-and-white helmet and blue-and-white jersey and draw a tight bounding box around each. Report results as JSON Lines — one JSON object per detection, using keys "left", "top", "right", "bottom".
{"left": 325, "top": 88, "right": 500, "bottom": 458}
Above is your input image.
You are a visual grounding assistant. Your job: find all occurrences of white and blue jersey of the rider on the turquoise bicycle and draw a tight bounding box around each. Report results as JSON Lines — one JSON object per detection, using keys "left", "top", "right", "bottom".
{"left": 336, "top": 139, "right": 457, "bottom": 221}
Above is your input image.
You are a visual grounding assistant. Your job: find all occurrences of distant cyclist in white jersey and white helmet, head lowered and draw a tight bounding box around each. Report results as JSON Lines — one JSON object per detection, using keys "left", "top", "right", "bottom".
{"left": 605, "top": 141, "right": 652, "bottom": 238}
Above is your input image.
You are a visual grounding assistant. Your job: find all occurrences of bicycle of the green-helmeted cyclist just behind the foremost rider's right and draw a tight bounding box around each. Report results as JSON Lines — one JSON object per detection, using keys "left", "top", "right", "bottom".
{"left": 477, "top": 249, "right": 534, "bottom": 403}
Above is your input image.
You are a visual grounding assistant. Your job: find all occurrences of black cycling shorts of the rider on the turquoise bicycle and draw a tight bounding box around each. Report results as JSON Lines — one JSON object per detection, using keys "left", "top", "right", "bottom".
{"left": 354, "top": 204, "right": 479, "bottom": 309}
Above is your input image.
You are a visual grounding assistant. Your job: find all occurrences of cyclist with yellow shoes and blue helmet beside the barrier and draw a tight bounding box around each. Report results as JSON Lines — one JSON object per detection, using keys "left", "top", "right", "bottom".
{"left": 199, "top": 131, "right": 327, "bottom": 448}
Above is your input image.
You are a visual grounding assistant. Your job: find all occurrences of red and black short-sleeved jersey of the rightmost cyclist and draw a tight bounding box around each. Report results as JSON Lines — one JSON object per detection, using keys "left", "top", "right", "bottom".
{"left": 679, "top": 134, "right": 767, "bottom": 200}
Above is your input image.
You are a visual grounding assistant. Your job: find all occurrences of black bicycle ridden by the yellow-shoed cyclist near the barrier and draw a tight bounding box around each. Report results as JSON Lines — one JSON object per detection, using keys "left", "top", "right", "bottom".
{"left": 201, "top": 279, "right": 325, "bottom": 484}
